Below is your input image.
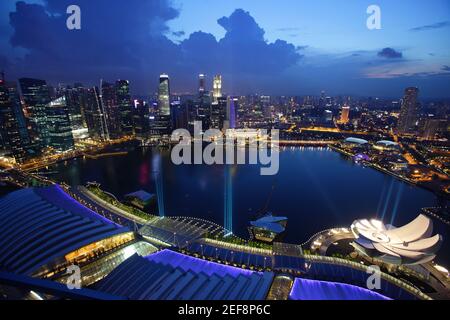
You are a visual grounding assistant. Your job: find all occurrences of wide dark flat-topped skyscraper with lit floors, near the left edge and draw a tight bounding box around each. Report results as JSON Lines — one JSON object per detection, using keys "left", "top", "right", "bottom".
{"left": 19, "top": 78, "right": 51, "bottom": 148}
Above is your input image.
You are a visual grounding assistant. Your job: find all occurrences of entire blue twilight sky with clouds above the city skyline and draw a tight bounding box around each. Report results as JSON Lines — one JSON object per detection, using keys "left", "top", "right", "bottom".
{"left": 0, "top": 0, "right": 450, "bottom": 98}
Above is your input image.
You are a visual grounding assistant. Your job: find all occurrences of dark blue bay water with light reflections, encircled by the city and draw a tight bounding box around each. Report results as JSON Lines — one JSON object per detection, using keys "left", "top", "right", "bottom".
{"left": 44, "top": 148, "right": 450, "bottom": 264}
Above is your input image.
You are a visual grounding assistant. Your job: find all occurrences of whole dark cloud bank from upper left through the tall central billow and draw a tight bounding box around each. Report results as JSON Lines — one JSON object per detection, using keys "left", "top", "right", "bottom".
{"left": 4, "top": 0, "right": 301, "bottom": 94}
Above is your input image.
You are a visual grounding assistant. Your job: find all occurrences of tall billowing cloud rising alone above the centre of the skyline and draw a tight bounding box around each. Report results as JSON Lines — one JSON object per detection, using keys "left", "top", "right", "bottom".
{"left": 179, "top": 9, "right": 302, "bottom": 93}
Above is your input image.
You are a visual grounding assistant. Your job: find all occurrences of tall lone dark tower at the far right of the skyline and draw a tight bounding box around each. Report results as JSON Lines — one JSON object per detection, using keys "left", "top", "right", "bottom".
{"left": 397, "top": 87, "right": 419, "bottom": 134}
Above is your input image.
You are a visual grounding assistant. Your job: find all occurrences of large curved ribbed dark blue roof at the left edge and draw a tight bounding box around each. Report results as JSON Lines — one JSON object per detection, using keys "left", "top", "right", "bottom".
{"left": 0, "top": 185, "right": 130, "bottom": 275}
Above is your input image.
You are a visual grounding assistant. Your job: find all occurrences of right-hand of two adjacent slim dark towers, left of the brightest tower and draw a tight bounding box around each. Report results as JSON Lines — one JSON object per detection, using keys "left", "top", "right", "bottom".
{"left": 116, "top": 80, "right": 133, "bottom": 135}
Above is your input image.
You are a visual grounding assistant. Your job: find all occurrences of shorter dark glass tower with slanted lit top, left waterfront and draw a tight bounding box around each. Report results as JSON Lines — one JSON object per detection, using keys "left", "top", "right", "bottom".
{"left": 47, "top": 96, "right": 74, "bottom": 151}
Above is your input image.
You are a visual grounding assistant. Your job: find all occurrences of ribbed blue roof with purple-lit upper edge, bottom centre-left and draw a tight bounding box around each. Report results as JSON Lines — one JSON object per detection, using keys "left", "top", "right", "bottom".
{"left": 95, "top": 250, "right": 273, "bottom": 300}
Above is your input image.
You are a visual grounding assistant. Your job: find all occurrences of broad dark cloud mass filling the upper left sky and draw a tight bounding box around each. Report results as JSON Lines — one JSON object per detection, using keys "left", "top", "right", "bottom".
{"left": 10, "top": 0, "right": 179, "bottom": 89}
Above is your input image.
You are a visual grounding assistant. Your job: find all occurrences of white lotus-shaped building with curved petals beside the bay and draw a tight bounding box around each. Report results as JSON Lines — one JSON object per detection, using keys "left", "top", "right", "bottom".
{"left": 351, "top": 215, "right": 442, "bottom": 264}
